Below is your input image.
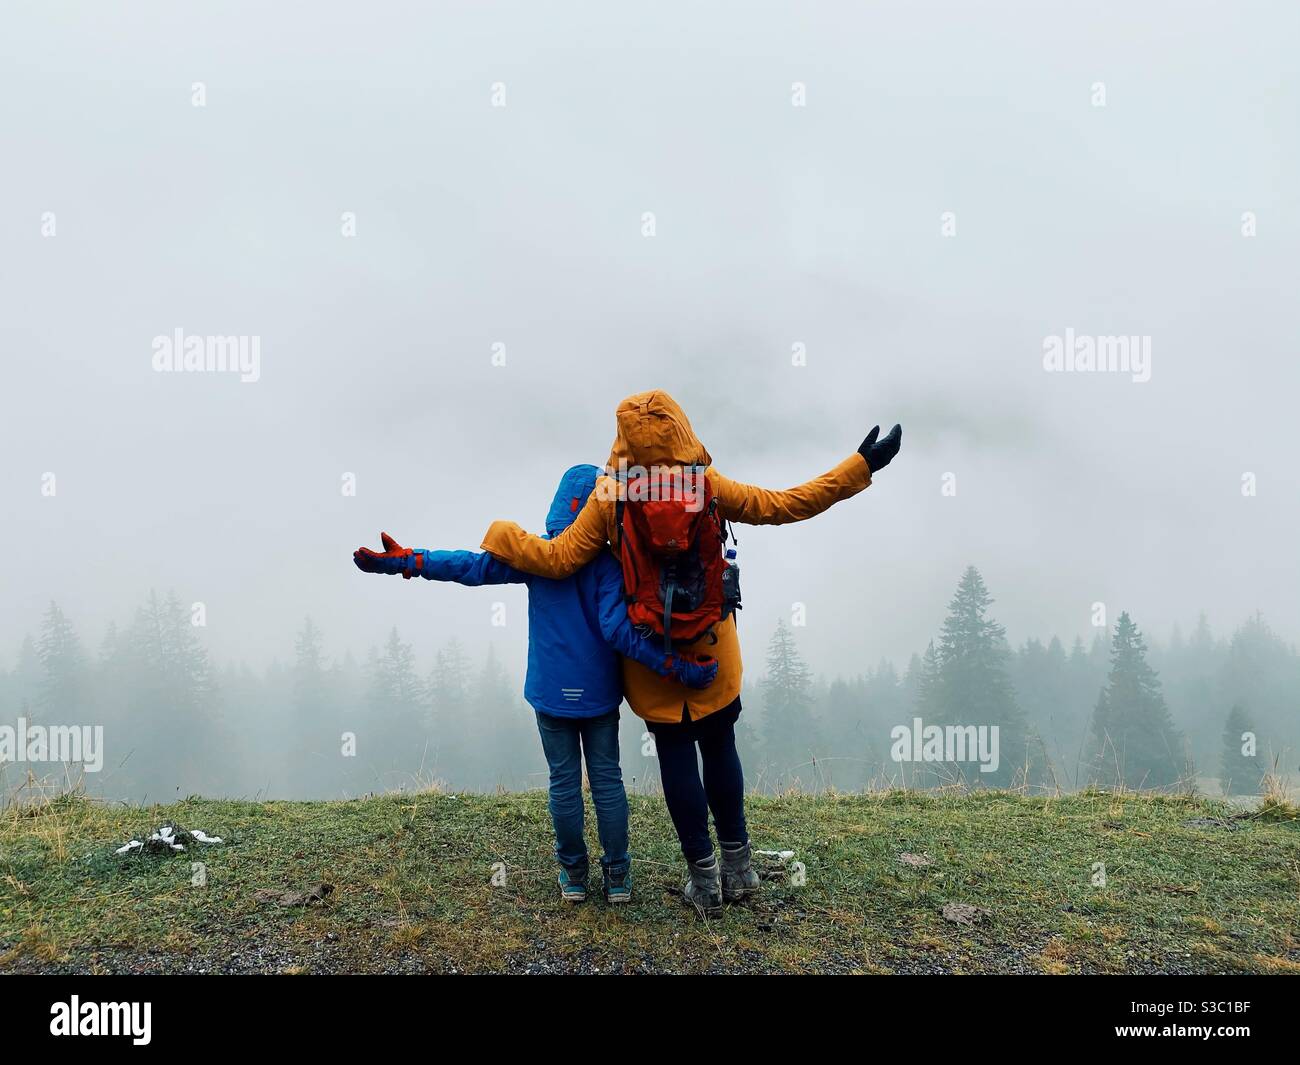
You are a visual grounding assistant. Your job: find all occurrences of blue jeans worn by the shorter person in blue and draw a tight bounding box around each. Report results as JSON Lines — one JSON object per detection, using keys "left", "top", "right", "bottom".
{"left": 537, "top": 709, "right": 631, "bottom": 875}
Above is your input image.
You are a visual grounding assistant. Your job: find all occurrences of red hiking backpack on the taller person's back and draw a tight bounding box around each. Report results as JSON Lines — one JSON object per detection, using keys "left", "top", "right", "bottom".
{"left": 615, "top": 467, "right": 740, "bottom": 654}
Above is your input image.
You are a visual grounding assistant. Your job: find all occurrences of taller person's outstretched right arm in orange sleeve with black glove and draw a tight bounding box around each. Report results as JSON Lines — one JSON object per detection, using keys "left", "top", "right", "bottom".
{"left": 710, "top": 425, "right": 902, "bottom": 525}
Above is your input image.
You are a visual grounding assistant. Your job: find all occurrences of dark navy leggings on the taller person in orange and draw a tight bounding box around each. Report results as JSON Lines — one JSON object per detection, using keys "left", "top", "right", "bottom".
{"left": 646, "top": 696, "right": 749, "bottom": 862}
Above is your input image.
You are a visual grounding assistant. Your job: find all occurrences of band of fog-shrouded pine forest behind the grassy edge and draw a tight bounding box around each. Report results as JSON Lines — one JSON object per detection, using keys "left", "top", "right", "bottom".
{"left": 0, "top": 567, "right": 1300, "bottom": 801}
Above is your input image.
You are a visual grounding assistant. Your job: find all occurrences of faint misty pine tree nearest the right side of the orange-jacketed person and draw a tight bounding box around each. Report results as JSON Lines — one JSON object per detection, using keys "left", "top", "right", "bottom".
{"left": 762, "top": 620, "right": 823, "bottom": 787}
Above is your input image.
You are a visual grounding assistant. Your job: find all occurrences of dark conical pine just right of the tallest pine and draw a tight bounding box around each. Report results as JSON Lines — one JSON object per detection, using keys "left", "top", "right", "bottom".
{"left": 1089, "top": 611, "right": 1191, "bottom": 788}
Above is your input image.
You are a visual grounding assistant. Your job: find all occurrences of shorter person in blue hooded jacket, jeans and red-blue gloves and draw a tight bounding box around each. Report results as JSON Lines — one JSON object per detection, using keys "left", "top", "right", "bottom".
{"left": 352, "top": 466, "right": 718, "bottom": 902}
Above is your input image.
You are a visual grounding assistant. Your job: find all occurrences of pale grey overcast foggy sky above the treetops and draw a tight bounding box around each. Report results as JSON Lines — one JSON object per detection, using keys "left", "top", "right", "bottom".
{"left": 0, "top": 0, "right": 1300, "bottom": 672}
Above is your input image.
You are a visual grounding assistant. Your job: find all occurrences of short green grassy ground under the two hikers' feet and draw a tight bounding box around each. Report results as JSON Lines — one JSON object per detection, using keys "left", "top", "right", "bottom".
{"left": 0, "top": 792, "right": 1300, "bottom": 973}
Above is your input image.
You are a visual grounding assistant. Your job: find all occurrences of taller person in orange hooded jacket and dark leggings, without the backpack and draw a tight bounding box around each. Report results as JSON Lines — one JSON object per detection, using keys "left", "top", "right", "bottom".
{"left": 482, "top": 390, "right": 902, "bottom": 915}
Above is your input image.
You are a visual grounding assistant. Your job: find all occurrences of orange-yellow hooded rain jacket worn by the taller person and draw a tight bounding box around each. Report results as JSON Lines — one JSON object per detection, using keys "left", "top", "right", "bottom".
{"left": 482, "top": 391, "right": 871, "bottom": 723}
